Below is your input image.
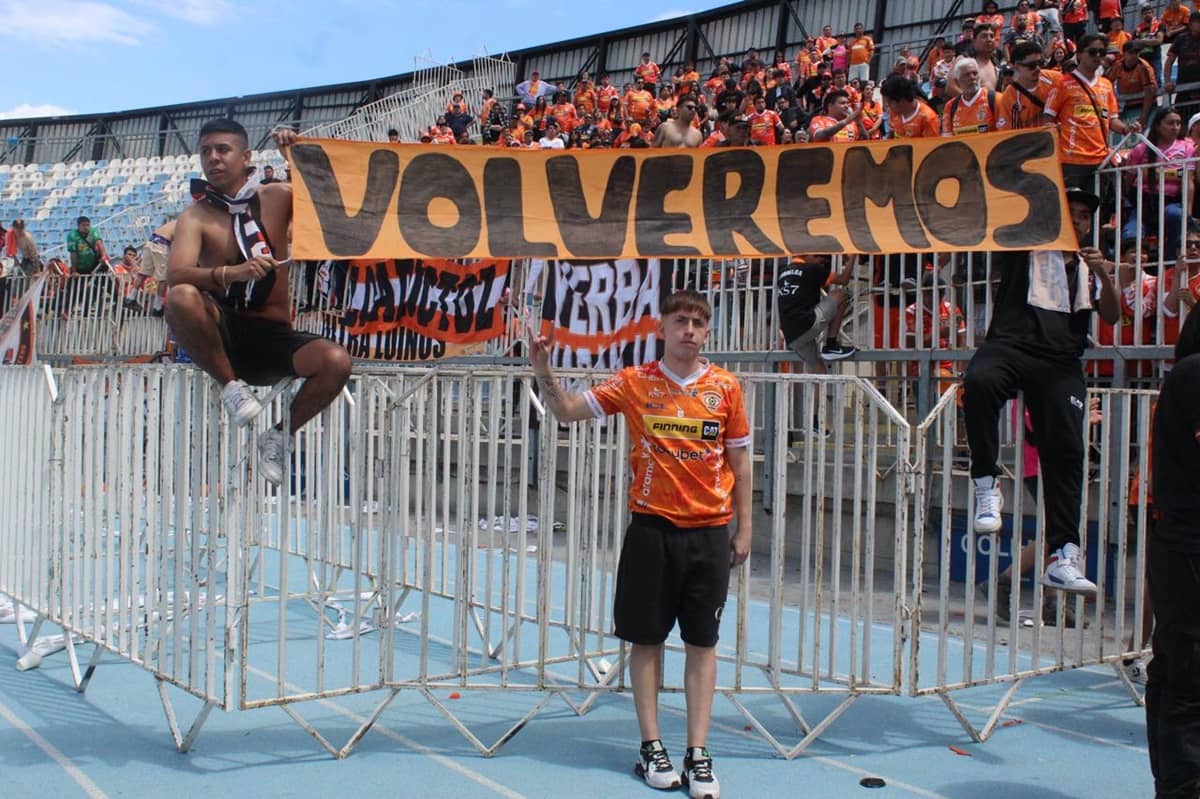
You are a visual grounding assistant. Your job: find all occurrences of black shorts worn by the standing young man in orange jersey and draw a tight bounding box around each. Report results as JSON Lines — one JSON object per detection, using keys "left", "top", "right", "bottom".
{"left": 612, "top": 513, "right": 731, "bottom": 647}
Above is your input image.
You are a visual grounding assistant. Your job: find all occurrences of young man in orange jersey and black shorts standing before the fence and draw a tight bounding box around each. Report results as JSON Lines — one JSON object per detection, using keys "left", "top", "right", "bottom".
{"left": 529, "top": 292, "right": 752, "bottom": 799}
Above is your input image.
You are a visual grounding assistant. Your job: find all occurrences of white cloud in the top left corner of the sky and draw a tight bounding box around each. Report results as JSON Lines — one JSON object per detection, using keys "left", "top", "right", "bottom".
{"left": 0, "top": 0, "right": 154, "bottom": 44}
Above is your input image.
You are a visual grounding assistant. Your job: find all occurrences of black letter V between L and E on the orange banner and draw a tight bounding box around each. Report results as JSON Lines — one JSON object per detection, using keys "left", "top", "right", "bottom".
{"left": 546, "top": 156, "right": 637, "bottom": 258}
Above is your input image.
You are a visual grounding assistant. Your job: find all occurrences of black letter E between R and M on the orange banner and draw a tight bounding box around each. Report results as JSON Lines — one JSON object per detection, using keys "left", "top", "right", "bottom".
{"left": 775, "top": 148, "right": 842, "bottom": 253}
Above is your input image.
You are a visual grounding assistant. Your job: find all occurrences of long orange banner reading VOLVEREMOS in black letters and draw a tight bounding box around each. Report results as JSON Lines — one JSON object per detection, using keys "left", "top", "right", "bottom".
{"left": 288, "top": 128, "right": 1079, "bottom": 259}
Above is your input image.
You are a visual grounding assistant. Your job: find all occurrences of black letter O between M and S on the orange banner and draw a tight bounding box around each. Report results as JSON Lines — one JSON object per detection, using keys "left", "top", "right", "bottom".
{"left": 913, "top": 142, "right": 988, "bottom": 247}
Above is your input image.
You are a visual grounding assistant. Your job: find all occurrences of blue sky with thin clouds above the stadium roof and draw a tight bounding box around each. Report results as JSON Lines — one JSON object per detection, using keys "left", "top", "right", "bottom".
{"left": 0, "top": 0, "right": 727, "bottom": 116}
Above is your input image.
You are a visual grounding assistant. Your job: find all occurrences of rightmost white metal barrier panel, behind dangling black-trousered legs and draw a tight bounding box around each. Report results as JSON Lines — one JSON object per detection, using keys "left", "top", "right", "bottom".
{"left": 907, "top": 386, "right": 1157, "bottom": 740}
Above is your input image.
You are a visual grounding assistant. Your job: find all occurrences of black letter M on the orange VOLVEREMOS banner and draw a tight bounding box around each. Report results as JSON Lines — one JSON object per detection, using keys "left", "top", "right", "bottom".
{"left": 841, "top": 144, "right": 929, "bottom": 252}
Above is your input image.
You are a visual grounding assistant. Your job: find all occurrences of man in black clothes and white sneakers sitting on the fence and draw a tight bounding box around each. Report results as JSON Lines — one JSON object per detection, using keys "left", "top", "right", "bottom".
{"left": 962, "top": 188, "right": 1121, "bottom": 594}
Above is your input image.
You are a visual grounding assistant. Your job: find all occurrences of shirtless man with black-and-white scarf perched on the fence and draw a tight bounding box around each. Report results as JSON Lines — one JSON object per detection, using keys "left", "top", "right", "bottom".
{"left": 167, "top": 119, "right": 350, "bottom": 485}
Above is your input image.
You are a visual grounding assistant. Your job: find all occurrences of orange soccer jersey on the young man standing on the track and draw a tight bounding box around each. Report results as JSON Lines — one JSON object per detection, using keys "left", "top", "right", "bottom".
{"left": 584, "top": 361, "right": 750, "bottom": 528}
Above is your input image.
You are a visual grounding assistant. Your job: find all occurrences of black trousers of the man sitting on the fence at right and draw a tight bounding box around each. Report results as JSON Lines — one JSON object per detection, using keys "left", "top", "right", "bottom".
{"left": 962, "top": 342, "right": 1087, "bottom": 552}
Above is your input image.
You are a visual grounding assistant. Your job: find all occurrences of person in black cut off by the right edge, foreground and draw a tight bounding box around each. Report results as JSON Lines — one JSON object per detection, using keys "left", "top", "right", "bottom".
{"left": 1146, "top": 312, "right": 1200, "bottom": 799}
